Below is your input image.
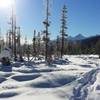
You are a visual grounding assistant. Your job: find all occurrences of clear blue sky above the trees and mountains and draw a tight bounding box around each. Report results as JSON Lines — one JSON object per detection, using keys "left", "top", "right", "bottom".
{"left": 0, "top": 0, "right": 100, "bottom": 39}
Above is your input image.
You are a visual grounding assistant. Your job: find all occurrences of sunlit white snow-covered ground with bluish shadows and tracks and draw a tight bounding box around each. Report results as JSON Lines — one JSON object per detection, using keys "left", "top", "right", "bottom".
{"left": 0, "top": 55, "right": 100, "bottom": 100}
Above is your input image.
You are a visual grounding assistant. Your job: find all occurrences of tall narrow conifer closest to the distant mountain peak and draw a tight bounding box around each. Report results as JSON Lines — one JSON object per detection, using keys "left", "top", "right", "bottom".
{"left": 60, "top": 5, "right": 67, "bottom": 58}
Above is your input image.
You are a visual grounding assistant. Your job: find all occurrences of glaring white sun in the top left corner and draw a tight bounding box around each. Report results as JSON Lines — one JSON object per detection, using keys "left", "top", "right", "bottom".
{"left": 0, "top": 0, "right": 14, "bottom": 8}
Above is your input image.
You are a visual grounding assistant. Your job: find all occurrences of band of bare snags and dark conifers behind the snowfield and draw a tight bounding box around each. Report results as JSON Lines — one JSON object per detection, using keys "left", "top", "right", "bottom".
{"left": 0, "top": 0, "right": 100, "bottom": 64}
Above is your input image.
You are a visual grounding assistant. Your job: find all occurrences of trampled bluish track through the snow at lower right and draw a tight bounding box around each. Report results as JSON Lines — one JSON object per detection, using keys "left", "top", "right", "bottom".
{"left": 70, "top": 68, "right": 100, "bottom": 100}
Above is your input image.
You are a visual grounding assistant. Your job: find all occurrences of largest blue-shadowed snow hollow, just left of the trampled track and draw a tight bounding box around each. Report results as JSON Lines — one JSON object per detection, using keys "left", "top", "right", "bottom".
{"left": 31, "top": 76, "right": 76, "bottom": 88}
